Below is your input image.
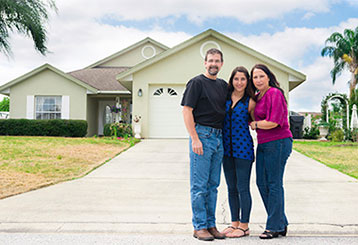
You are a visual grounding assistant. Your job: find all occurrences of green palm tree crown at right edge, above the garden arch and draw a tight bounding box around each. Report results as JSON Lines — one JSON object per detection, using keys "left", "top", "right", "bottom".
{"left": 321, "top": 27, "right": 358, "bottom": 97}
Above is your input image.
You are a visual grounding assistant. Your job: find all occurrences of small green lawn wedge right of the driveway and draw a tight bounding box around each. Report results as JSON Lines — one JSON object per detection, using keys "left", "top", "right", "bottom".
{"left": 293, "top": 141, "right": 358, "bottom": 179}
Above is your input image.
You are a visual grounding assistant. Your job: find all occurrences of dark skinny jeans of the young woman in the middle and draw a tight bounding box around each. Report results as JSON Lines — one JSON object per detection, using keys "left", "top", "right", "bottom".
{"left": 223, "top": 156, "right": 252, "bottom": 223}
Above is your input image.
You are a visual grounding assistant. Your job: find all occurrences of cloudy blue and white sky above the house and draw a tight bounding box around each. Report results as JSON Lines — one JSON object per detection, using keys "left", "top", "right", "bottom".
{"left": 0, "top": 0, "right": 358, "bottom": 112}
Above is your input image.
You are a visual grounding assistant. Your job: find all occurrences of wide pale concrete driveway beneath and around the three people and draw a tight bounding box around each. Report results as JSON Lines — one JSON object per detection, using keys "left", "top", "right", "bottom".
{"left": 0, "top": 140, "right": 358, "bottom": 239}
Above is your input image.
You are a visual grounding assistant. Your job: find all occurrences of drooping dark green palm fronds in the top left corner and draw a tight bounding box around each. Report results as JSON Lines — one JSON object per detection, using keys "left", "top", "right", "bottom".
{"left": 0, "top": 0, "right": 57, "bottom": 55}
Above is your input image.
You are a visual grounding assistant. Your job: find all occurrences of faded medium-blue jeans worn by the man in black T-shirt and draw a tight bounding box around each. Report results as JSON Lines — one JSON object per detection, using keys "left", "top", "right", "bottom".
{"left": 189, "top": 124, "right": 224, "bottom": 230}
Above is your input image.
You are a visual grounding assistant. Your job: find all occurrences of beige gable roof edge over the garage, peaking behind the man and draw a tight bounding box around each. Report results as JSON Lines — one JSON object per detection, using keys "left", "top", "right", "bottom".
{"left": 116, "top": 29, "right": 306, "bottom": 89}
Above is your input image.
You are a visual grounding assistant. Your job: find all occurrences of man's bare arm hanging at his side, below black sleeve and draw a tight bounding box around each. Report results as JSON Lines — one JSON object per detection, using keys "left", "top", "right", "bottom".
{"left": 183, "top": 106, "right": 203, "bottom": 155}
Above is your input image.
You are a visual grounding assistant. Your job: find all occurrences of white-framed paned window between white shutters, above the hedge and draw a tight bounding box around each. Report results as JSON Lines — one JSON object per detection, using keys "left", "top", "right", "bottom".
{"left": 35, "top": 96, "right": 62, "bottom": 119}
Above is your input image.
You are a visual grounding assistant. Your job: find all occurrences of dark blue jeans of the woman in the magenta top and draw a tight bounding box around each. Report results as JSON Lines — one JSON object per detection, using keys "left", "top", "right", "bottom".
{"left": 256, "top": 138, "right": 292, "bottom": 232}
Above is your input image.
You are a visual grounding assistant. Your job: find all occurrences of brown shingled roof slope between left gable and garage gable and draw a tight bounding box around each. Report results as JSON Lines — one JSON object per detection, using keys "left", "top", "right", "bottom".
{"left": 68, "top": 67, "right": 130, "bottom": 92}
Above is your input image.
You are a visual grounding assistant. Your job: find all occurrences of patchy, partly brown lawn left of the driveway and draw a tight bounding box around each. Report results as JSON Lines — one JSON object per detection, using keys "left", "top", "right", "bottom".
{"left": 0, "top": 136, "right": 138, "bottom": 199}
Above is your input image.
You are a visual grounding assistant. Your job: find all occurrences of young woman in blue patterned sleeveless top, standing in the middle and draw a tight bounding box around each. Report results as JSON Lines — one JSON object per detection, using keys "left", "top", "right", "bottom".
{"left": 223, "top": 66, "right": 256, "bottom": 238}
